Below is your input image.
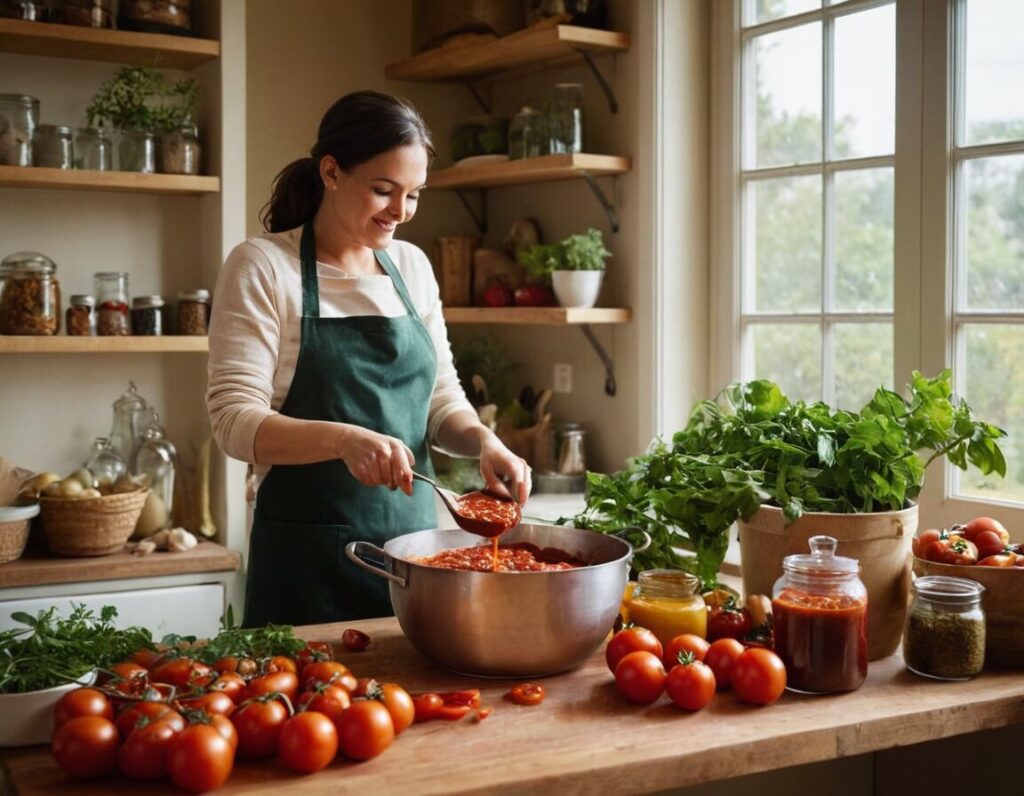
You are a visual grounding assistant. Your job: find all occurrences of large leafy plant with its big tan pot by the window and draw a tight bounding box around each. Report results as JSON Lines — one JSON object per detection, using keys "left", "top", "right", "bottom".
{"left": 577, "top": 370, "right": 1006, "bottom": 659}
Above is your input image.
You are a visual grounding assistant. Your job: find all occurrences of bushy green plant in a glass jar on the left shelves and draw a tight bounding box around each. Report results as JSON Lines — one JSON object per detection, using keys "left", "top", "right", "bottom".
{"left": 86, "top": 67, "right": 199, "bottom": 172}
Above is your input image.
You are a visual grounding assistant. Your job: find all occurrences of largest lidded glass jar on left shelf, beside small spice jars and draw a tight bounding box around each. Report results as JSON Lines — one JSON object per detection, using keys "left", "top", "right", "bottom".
{"left": 0, "top": 252, "right": 60, "bottom": 335}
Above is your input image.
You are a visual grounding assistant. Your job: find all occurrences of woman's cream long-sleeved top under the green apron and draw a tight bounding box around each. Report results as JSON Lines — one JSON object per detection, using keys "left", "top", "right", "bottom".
{"left": 206, "top": 227, "right": 473, "bottom": 480}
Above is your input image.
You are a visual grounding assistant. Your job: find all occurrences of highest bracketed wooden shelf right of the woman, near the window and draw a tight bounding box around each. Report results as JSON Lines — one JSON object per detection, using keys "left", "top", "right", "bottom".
{"left": 385, "top": 25, "right": 630, "bottom": 81}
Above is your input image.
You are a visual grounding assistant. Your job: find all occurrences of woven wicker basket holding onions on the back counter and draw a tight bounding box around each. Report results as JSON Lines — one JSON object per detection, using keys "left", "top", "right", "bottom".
{"left": 40, "top": 490, "right": 150, "bottom": 556}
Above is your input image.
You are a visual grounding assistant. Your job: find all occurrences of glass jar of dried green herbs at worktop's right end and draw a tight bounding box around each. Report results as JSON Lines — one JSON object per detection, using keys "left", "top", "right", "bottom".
{"left": 903, "top": 575, "right": 985, "bottom": 680}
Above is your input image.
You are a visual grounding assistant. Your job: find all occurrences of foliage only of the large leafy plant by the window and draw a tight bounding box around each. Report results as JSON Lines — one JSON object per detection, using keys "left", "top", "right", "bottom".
{"left": 575, "top": 370, "right": 1007, "bottom": 583}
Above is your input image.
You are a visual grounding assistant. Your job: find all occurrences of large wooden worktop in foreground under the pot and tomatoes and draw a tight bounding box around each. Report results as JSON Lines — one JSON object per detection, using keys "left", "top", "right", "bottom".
{"left": 0, "top": 619, "right": 1024, "bottom": 796}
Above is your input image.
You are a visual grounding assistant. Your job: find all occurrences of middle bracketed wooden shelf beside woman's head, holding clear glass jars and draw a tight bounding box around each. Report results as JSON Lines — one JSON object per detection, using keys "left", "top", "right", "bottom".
{"left": 427, "top": 153, "right": 630, "bottom": 188}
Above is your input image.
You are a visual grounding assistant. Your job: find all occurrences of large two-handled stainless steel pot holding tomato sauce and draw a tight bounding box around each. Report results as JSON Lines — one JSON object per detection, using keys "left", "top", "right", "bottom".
{"left": 345, "top": 525, "right": 650, "bottom": 677}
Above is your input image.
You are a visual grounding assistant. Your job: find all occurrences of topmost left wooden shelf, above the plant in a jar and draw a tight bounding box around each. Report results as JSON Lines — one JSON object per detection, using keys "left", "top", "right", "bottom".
{"left": 0, "top": 19, "right": 220, "bottom": 70}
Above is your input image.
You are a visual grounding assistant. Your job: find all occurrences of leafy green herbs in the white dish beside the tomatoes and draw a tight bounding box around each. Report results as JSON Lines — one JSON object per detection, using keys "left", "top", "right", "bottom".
{"left": 0, "top": 604, "right": 154, "bottom": 694}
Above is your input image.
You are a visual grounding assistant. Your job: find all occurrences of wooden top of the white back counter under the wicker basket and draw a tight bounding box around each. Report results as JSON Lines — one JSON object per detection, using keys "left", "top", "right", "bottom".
{"left": 0, "top": 542, "right": 242, "bottom": 589}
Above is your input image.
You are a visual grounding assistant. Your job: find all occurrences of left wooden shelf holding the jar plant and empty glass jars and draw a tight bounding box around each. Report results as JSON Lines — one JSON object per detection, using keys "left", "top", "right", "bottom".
{"left": 0, "top": 166, "right": 220, "bottom": 196}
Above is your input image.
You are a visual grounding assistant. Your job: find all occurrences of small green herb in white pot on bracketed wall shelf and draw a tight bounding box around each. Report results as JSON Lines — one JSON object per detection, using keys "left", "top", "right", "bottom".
{"left": 518, "top": 229, "right": 611, "bottom": 307}
